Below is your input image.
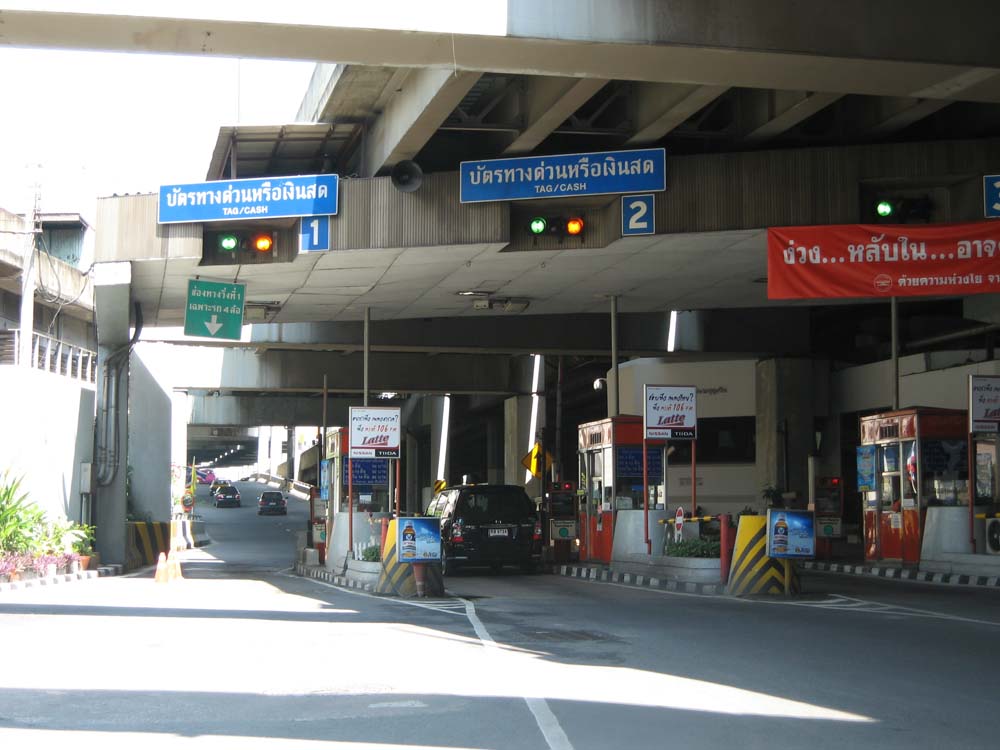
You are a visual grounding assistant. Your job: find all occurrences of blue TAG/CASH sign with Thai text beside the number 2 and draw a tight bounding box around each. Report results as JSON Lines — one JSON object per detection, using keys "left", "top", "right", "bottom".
{"left": 459, "top": 148, "right": 667, "bottom": 203}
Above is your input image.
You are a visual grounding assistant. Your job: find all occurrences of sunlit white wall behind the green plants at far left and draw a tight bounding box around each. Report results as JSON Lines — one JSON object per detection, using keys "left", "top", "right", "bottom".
{"left": 0, "top": 366, "right": 95, "bottom": 521}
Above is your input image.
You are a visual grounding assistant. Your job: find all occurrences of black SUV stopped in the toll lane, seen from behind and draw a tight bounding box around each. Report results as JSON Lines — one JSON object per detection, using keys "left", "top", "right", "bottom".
{"left": 427, "top": 484, "right": 542, "bottom": 575}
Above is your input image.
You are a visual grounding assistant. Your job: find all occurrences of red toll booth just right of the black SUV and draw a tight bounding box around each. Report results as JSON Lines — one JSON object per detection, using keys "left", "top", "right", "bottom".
{"left": 577, "top": 416, "right": 667, "bottom": 563}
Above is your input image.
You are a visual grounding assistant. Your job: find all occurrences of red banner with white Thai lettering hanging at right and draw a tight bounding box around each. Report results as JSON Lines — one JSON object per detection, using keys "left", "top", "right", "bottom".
{"left": 767, "top": 221, "right": 1000, "bottom": 299}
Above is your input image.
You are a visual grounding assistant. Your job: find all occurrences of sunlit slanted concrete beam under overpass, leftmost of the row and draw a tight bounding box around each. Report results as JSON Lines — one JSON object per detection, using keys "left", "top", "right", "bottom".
{"left": 361, "top": 69, "right": 480, "bottom": 176}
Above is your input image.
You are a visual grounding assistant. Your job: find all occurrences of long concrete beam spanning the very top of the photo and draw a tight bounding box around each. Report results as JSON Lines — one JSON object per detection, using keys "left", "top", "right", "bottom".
{"left": 0, "top": 0, "right": 1000, "bottom": 102}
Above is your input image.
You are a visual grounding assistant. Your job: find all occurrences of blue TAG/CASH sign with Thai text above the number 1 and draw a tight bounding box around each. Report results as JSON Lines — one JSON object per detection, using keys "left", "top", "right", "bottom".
{"left": 158, "top": 174, "right": 339, "bottom": 224}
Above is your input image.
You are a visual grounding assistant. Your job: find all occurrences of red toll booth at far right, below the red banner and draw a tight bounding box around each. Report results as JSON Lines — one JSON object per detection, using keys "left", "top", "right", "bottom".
{"left": 857, "top": 407, "right": 969, "bottom": 564}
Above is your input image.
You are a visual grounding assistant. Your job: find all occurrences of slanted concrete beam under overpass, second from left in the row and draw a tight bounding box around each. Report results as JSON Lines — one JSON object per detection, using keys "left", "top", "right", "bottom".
{"left": 503, "top": 77, "right": 608, "bottom": 154}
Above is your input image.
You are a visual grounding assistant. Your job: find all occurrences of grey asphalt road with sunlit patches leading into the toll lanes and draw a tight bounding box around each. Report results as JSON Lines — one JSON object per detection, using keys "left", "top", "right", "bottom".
{"left": 0, "top": 485, "right": 1000, "bottom": 750}
